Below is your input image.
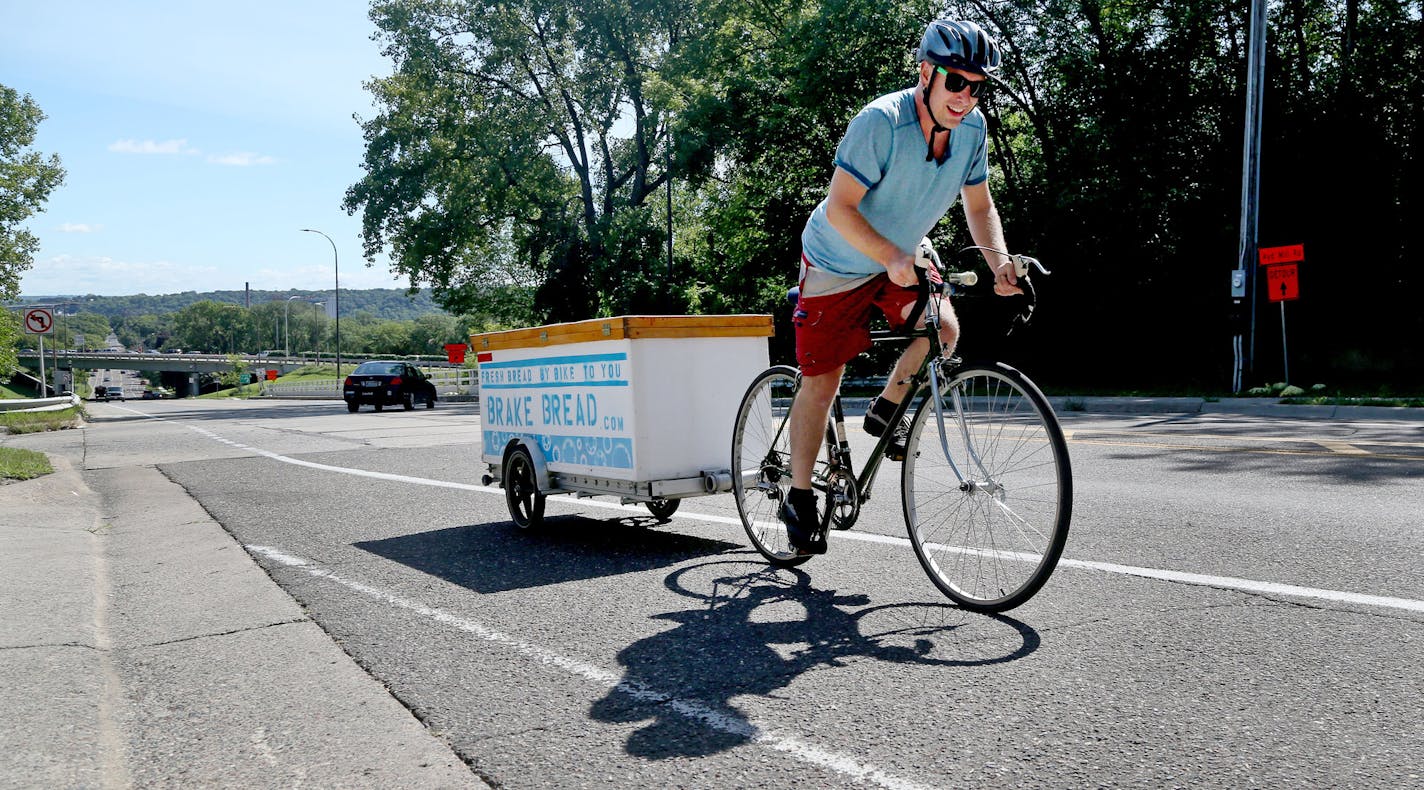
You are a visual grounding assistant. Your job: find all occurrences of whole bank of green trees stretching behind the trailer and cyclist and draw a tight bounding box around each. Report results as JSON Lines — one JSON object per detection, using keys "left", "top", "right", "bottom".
{"left": 346, "top": 0, "right": 1424, "bottom": 389}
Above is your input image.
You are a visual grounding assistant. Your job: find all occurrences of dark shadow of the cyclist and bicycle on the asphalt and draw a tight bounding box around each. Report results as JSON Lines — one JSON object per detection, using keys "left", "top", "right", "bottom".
{"left": 590, "top": 559, "right": 1040, "bottom": 759}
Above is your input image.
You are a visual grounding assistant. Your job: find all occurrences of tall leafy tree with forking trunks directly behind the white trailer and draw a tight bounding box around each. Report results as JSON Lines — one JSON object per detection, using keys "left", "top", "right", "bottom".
{"left": 345, "top": 0, "right": 691, "bottom": 320}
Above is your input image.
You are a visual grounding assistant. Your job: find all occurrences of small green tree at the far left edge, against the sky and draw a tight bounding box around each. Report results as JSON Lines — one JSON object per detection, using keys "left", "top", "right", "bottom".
{"left": 0, "top": 85, "right": 64, "bottom": 373}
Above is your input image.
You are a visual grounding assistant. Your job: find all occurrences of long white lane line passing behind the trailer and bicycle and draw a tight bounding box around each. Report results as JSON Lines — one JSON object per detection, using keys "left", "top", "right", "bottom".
{"left": 147, "top": 417, "right": 1424, "bottom": 612}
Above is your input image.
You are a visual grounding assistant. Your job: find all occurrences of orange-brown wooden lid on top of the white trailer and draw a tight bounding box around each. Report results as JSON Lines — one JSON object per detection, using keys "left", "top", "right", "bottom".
{"left": 470, "top": 315, "right": 775, "bottom": 352}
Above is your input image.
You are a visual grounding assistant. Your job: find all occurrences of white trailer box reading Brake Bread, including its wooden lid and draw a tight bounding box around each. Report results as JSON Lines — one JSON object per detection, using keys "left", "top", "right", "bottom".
{"left": 470, "top": 315, "right": 772, "bottom": 497}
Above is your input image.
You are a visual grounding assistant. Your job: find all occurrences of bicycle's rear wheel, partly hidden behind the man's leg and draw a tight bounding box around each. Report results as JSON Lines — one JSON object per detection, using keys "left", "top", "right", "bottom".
{"left": 732, "top": 364, "right": 830, "bottom": 568}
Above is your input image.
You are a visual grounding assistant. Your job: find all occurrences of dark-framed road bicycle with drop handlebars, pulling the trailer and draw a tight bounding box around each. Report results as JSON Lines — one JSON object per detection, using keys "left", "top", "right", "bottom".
{"left": 732, "top": 246, "right": 1072, "bottom": 612}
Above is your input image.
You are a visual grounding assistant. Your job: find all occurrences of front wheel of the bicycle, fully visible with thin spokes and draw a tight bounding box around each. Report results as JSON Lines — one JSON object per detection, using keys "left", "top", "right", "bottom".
{"left": 900, "top": 364, "right": 1072, "bottom": 612}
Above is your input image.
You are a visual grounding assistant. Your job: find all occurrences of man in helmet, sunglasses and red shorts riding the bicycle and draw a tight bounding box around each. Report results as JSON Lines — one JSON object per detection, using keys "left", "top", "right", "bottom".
{"left": 780, "top": 20, "right": 1022, "bottom": 554}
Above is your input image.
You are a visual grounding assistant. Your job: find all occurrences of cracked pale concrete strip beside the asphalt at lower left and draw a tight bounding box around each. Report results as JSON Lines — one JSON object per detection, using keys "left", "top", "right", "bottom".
{"left": 0, "top": 450, "right": 487, "bottom": 790}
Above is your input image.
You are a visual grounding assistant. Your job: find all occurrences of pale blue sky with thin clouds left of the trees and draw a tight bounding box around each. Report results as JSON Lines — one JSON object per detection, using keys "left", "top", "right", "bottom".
{"left": 0, "top": 0, "right": 406, "bottom": 296}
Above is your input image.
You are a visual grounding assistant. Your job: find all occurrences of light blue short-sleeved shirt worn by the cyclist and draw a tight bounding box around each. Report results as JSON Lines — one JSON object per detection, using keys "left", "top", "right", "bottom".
{"left": 802, "top": 88, "right": 988, "bottom": 278}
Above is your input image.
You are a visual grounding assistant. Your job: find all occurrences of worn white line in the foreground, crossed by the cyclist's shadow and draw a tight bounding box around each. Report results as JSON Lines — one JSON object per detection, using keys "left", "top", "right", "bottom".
{"left": 246, "top": 545, "right": 926, "bottom": 790}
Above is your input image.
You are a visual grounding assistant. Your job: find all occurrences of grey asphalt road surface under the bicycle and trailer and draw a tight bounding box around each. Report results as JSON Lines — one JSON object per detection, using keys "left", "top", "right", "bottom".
{"left": 64, "top": 400, "right": 1424, "bottom": 789}
